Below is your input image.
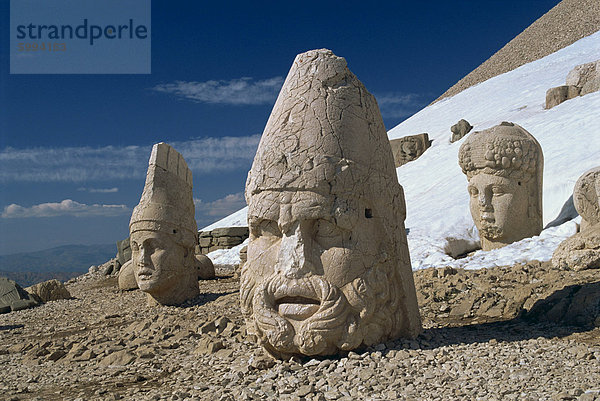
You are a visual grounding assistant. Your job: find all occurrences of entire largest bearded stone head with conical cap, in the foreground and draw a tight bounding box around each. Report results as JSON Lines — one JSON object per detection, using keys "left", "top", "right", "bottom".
{"left": 240, "top": 49, "right": 421, "bottom": 357}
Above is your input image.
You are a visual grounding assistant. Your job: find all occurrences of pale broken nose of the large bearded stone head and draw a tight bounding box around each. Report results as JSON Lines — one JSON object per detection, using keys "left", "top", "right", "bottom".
{"left": 276, "top": 223, "right": 313, "bottom": 279}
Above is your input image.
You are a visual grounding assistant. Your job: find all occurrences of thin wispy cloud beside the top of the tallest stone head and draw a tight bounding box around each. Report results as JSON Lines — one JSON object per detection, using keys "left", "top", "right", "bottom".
{"left": 152, "top": 77, "right": 283, "bottom": 105}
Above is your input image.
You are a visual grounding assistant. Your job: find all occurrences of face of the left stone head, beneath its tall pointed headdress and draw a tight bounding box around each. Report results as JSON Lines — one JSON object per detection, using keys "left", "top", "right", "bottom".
{"left": 130, "top": 230, "right": 189, "bottom": 297}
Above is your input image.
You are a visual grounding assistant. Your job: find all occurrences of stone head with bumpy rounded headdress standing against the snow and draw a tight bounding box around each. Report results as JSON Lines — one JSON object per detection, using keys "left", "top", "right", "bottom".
{"left": 458, "top": 122, "right": 544, "bottom": 251}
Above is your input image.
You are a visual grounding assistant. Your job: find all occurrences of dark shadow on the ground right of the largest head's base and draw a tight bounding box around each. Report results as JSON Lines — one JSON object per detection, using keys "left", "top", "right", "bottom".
{"left": 412, "top": 281, "right": 600, "bottom": 349}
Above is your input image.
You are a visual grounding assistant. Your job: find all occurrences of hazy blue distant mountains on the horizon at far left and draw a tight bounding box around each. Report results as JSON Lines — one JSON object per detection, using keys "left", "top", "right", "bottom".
{"left": 0, "top": 244, "right": 117, "bottom": 287}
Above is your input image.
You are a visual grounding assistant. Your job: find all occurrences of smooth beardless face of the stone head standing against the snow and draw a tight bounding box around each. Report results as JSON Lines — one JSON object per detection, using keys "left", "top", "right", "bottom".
{"left": 468, "top": 173, "right": 528, "bottom": 249}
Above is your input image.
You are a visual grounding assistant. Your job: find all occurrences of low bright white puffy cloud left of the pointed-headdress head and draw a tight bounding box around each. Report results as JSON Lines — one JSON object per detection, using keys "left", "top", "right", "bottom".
{"left": 0, "top": 199, "right": 131, "bottom": 219}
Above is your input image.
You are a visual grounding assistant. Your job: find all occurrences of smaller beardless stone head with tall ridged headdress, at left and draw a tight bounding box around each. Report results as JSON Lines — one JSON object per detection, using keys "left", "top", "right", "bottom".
{"left": 129, "top": 143, "right": 199, "bottom": 305}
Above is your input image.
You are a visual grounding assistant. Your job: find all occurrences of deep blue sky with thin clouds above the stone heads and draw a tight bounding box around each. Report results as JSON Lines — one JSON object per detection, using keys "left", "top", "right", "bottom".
{"left": 0, "top": 0, "right": 559, "bottom": 254}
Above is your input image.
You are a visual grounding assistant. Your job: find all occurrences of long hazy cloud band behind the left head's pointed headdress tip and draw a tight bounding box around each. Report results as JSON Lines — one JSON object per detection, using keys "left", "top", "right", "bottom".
{"left": 0, "top": 134, "right": 260, "bottom": 184}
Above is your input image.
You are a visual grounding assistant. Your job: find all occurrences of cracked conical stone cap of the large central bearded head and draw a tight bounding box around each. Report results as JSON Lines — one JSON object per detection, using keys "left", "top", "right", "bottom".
{"left": 246, "top": 49, "right": 398, "bottom": 202}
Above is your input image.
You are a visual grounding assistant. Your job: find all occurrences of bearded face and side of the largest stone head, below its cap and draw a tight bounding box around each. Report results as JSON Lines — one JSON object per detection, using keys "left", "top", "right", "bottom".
{"left": 240, "top": 186, "right": 420, "bottom": 357}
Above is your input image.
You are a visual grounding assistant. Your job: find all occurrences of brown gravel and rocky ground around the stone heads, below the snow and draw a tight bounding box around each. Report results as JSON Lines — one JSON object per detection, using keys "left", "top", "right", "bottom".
{"left": 0, "top": 262, "right": 600, "bottom": 400}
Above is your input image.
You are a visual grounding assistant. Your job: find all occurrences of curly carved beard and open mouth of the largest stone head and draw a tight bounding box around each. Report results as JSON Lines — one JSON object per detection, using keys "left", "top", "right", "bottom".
{"left": 240, "top": 266, "right": 400, "bottom": 358}
